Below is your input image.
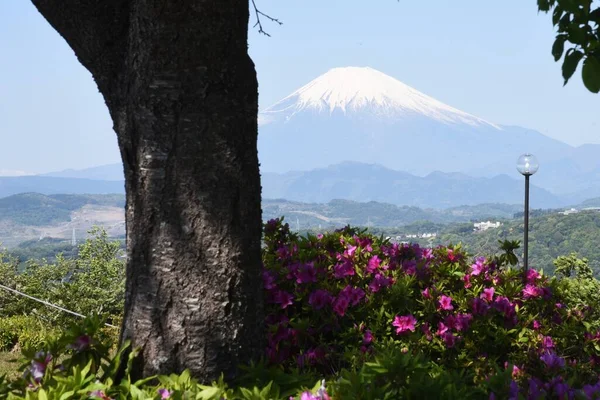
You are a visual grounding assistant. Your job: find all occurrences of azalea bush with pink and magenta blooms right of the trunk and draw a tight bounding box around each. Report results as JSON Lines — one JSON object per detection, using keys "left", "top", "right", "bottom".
{"left": 263, "top": 220, "right": 600, "bottom": 398}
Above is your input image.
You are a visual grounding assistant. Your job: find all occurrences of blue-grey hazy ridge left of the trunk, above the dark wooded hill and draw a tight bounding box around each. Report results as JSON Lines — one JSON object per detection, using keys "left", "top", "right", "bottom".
{"left": 0, "top": 176, "right": 125, "bottom": 197}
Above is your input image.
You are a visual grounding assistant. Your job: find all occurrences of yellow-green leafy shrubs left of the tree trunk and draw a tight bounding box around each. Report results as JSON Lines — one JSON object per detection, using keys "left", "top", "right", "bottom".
{"left": 0, "top": 229, "right": 125, "bottom": 350}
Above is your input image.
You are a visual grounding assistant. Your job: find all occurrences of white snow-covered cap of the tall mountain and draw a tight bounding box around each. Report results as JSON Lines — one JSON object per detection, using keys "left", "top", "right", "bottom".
{"left": 259, "top": 67, "right": 500, "bottom": 129}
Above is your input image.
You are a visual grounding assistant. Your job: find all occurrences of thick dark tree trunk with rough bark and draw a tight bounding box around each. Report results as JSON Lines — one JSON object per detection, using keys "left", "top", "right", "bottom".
{"left": 32, "top": 0, "right": 263, "bottom": 380}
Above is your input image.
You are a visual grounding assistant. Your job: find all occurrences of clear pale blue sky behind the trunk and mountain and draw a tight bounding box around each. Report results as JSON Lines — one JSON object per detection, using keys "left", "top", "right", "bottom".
{"left": 0, "top": 0, "right": 600, "bottom": 172}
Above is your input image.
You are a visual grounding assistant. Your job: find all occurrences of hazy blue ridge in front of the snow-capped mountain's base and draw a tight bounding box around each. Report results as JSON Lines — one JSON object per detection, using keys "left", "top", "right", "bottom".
{"left": 262, "top": 162, "right": 569, "bottom": 208}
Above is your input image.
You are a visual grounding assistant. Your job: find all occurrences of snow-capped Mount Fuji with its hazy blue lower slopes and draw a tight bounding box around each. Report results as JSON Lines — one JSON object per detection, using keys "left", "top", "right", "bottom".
{"left": 258, "top": 67, "right": 573, "bottom": 176}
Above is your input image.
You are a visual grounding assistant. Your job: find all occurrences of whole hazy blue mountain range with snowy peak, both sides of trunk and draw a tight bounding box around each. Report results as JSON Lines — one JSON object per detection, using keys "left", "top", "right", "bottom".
{"left": 0, "top": 67, "right": 600, "bottom": 208}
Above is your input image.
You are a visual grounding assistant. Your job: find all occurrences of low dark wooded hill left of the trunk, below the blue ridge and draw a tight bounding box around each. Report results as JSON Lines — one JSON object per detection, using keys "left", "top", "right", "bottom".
{"left": 0, "top": 193, "right": 125, "bottom": 226}
